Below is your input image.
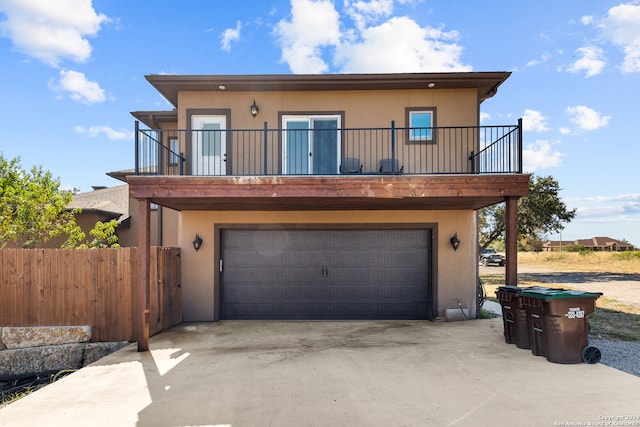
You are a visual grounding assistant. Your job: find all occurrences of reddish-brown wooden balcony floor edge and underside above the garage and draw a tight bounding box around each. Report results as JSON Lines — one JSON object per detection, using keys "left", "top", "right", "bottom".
{"left": 127, "top": 174, "right": 529, "bottom": 211}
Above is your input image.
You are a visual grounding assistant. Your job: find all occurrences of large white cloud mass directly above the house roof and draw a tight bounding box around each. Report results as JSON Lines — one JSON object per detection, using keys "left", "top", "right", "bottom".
{"left": 274, "top": 0, "right": 471, "bottom": 73}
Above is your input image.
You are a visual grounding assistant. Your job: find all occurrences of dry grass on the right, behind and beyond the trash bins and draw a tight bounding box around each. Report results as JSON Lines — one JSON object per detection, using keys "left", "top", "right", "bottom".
{"left": 481, "top": 252, "right": 640, "bottom": 341}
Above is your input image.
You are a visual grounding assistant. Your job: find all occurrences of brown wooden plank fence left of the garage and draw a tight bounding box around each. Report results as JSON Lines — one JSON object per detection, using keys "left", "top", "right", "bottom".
{"left": 0, "top": 247, "right": 182, "bottom": 341}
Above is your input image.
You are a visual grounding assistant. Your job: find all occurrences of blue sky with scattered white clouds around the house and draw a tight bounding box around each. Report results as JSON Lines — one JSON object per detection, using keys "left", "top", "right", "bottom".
{"left": 0, "top": 0, "right": 640, "bottom": 245}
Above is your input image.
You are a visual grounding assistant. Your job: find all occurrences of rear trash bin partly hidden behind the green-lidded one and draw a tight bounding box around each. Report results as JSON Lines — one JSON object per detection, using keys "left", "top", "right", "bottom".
{"left": 496, "top": 286, "right": 531, "bottom": 349}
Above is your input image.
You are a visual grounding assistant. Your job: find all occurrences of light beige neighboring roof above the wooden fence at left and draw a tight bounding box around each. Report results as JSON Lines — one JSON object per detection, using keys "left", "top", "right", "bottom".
{"left": 69, "top": 184, "right": 129, "bottom": 224}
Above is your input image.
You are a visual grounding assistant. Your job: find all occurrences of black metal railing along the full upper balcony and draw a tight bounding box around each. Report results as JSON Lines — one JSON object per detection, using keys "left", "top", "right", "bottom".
{"left": 135, "top": 120, "right": 522, "bottom": 176}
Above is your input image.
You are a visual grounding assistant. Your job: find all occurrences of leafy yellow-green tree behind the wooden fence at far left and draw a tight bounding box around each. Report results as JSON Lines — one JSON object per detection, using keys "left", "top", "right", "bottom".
{"left": 0, "top": 153, "right": 78, "bottom": 248}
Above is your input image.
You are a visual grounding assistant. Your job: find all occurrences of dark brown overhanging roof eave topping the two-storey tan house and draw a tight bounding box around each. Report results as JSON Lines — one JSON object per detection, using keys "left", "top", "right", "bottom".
{"left": 144, "top": 71, "right": 511, "bottom": 108}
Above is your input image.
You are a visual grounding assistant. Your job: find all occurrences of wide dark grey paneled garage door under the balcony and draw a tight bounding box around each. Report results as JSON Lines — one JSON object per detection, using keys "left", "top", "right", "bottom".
{"left": 220, "top": 229, "right": 431, "bottom": 320}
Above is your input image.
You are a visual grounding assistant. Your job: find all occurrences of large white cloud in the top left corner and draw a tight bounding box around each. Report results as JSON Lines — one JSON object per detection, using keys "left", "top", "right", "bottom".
{"left": 0, "top": 0, "right": 109, "bottom": 67}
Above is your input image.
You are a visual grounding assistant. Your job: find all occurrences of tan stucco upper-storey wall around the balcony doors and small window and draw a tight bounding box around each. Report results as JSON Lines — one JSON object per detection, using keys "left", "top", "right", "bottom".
{"left": 178, "top": 89, "right": 478, "bottom": 174}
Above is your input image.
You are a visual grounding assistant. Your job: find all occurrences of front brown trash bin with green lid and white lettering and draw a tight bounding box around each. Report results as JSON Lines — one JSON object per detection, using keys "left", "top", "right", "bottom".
{"left": 520, "top": 288, "right": 602, "bottom": 363}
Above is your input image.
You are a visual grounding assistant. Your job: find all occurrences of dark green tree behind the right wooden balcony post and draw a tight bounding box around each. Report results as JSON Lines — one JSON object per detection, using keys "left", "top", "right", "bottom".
{"left": 479, "top": 175, "right": 576, "bottom": 249}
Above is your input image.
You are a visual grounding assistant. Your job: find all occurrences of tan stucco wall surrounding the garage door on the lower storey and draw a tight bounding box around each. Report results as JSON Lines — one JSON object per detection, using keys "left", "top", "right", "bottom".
{"left": 179, "top": 211, "right": 477, "bottom": 321}
